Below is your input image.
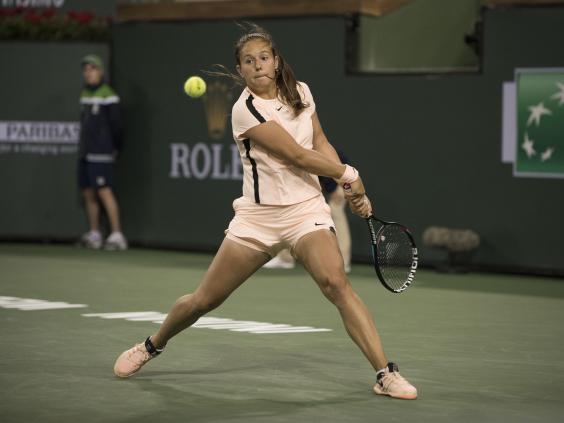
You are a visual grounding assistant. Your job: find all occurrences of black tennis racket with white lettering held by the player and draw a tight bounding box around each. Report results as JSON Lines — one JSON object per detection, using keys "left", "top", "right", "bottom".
{"left": 366, "top": 216, "right": 419, "bottom": 294}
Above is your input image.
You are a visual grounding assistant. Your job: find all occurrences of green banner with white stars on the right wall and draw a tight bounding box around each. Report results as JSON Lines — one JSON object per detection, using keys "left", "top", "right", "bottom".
{"left": 514, "top": 68, "right": 564, "bottom": 178}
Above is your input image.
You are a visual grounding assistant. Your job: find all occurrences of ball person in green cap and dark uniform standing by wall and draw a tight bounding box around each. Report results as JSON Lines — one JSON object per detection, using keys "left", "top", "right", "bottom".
{"left": 78, "top": 54, "right": 127, "bottom": 250}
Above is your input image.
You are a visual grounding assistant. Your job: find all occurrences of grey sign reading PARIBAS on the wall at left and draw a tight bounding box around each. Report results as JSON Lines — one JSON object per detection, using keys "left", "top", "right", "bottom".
{"left": 0, "top": 121, "right": 80, "bottom": 156}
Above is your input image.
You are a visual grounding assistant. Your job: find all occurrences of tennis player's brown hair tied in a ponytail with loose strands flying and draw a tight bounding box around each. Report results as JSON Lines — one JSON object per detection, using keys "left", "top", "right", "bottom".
{"left": 207, "top": 22, "right": 309, "bottom": 116}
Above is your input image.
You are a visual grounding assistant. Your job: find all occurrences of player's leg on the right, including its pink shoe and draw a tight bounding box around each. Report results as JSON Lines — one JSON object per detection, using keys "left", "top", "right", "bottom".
{"left": 295, "top": 230, "right": 417, "bottom": 399}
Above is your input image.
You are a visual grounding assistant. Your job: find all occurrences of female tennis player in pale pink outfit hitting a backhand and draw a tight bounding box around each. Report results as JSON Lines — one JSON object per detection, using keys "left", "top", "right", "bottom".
{"left": 114, "top": 26, "right": 417, "bottom": 399}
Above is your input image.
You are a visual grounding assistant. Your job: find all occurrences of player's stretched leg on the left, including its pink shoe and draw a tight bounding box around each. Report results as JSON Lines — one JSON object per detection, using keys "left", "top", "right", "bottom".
{"left": 114, "top": 238, "right": 270, "bottom": 377}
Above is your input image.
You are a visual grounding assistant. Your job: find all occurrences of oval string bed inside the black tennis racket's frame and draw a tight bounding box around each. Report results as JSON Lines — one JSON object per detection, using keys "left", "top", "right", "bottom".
{"left": 376, "top": 225, "right": 413, "bottom": 290}
